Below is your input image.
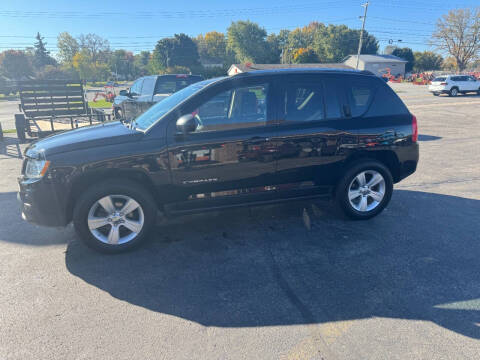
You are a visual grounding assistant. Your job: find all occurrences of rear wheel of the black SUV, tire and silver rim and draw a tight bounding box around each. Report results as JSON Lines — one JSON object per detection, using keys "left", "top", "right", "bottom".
{"left": 335, "top": 160, "right": 393, "bottom": 220}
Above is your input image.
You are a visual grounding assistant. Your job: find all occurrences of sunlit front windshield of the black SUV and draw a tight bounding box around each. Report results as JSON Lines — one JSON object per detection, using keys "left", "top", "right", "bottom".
{"left": 132, "top": 78, "right": 220, "bottom": 131}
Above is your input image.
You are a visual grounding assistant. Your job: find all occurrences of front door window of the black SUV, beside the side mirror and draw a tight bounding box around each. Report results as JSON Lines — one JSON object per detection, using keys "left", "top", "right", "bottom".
{"left": 195, "top": 84, "right": 268, "bottom": 132}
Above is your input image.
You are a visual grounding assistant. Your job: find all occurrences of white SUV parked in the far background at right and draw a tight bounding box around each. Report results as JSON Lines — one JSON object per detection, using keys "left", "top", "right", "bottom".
{"left": 428, "top": 75, "right": 480, "bottom": 96}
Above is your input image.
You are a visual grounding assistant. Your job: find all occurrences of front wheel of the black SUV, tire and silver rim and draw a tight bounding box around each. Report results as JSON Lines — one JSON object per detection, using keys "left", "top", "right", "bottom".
{"left": 73, "top": 180, "right": 157, "bottom": 253}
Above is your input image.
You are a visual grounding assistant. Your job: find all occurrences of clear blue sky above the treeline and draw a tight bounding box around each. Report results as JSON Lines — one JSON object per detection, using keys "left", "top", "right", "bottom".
{"left": 0, "top": 0, "right": 480, "bottom": 54}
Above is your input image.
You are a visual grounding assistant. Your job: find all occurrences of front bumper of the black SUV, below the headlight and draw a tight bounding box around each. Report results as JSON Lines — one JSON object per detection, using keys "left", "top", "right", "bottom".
{"left": 17, "top": 178, "right": 69, "bottom": 227}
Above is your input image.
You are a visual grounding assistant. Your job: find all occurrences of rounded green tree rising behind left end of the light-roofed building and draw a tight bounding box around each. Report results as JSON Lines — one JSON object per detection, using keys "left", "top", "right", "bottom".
{"left": 227, "top": 20, "right": 270, "bottom": 63}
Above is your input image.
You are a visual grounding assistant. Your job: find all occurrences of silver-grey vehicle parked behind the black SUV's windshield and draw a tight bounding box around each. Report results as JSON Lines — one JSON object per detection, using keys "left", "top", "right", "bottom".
{"left": 113, "top": 74, "right": 203, "bottom": 120}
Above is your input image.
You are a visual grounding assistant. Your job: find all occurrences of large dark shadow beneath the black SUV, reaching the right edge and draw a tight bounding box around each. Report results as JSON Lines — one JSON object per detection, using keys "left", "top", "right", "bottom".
{"left": 60, "top": 190, "right": 480, "bottom": 339}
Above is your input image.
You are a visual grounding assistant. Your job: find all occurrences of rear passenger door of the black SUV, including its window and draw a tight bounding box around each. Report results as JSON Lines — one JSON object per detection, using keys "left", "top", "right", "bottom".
{"left": 274, "top": 74, "right": 349, "bottom": 192}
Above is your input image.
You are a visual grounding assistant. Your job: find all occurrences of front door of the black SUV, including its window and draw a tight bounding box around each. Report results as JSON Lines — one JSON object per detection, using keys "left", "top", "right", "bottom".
{"left": 167, "top": 78, "right": 275, "bottom": 204}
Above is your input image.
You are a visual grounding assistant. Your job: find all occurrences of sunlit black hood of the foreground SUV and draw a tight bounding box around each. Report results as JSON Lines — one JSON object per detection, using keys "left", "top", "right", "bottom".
{"left": 26, "top": 121, "right": 144, "bottom": 157}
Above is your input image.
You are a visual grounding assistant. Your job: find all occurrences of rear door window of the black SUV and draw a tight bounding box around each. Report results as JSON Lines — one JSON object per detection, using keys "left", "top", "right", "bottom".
{"left": 283, "top": 82, "right": 324, "bottom": 123}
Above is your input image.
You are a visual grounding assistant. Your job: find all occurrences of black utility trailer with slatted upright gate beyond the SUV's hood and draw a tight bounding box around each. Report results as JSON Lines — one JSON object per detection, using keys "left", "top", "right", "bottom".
{"left": 15, "top": 80, "right": 111, "bottom": 141}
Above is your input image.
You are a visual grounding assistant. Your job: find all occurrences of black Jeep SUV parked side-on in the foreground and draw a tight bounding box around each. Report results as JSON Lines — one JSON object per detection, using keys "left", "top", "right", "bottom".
{"left": 19, "top": 69, "right": 418, "bottom": 252}
